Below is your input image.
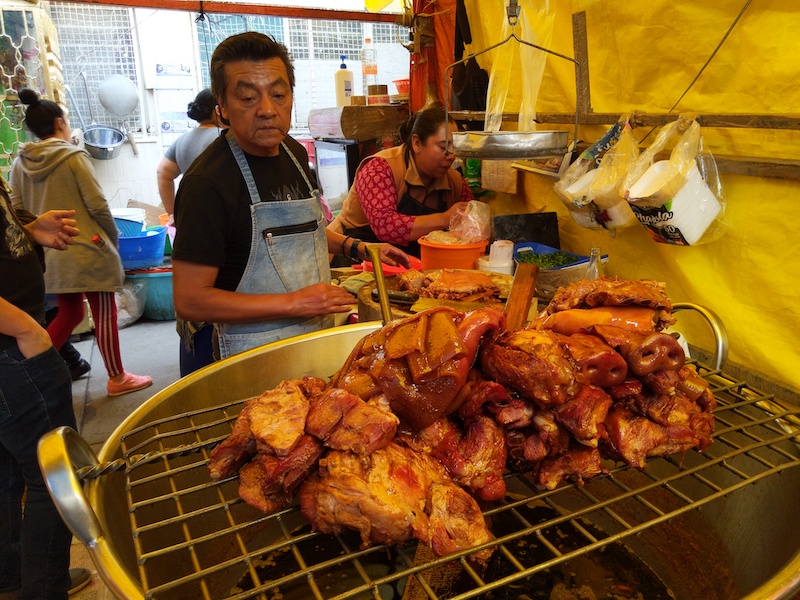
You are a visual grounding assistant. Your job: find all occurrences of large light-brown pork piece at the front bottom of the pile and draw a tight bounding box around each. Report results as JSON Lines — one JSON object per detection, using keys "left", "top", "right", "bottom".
{"left": 299, "top": 443, "right": 491, "bottom": 562}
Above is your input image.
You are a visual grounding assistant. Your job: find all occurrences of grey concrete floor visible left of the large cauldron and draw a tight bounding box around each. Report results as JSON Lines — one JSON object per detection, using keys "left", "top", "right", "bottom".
{"left": 66, "top": 319, "right": 180, "bottom": 600}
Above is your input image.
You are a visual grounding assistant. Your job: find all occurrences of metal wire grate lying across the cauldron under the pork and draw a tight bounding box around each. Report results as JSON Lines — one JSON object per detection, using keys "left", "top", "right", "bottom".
{"left": 117, "top": 365, "right": 800, "bottom": 599}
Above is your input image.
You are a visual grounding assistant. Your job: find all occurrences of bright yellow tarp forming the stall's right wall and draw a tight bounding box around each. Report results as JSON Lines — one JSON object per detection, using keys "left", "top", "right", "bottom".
{"left": 466, "top": 0, "right": 800, "bottom": 389}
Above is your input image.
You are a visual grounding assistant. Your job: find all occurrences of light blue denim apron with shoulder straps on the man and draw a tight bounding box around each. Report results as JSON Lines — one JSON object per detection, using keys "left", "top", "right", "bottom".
{"left": 214, "top": 131, "right": 334, "bottom": 358}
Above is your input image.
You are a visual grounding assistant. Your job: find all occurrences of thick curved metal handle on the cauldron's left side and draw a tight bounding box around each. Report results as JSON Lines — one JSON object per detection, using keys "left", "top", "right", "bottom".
{"left": 38, "top": 427, "right": 144, "bottom": 600}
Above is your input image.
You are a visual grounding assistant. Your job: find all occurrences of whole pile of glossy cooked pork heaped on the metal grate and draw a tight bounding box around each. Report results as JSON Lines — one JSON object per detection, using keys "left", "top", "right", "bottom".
{"left": 209, "top": 278, "right": 715, "bottom": 564}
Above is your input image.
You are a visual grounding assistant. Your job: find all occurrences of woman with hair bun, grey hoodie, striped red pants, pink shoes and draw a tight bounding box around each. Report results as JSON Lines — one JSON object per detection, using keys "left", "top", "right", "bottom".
{"left": 11, "top": 89, "right": 152, "bottom": 396}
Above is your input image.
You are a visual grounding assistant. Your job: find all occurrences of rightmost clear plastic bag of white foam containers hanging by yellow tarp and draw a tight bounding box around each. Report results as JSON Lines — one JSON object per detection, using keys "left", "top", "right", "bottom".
{"left": 626, "top": 118, "right": 726, "bottom": 246}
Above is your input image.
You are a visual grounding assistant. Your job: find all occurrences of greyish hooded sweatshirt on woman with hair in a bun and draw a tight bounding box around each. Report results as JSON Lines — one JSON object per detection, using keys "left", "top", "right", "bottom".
{"left": 10, "top": 138, "right": 125, "bottom": 294}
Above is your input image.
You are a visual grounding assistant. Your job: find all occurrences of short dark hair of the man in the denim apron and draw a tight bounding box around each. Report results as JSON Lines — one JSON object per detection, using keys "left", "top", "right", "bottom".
{"left": 210, "top": 31, "right": 294, "bottom": 99}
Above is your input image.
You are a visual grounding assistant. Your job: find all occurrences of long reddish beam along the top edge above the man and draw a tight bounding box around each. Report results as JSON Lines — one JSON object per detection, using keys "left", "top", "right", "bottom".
{"left": 56, "top": 0, "right": 402, "bottom": 23}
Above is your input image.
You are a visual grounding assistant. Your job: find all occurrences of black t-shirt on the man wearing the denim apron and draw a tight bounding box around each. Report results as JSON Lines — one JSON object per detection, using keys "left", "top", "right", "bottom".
{"left": 172, "top": 136, "right": 315, "bottom": 291}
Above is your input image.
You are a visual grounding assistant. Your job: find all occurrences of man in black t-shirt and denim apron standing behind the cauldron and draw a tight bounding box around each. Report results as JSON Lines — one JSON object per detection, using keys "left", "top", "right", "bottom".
{"left": 172, "top": 32, "right": 409, "bottom": 358}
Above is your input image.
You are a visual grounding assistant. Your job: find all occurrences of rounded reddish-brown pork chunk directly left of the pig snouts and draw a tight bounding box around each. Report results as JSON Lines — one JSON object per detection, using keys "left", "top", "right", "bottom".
{"left": 481, "top": 329, "right": 578, "bottom": 408}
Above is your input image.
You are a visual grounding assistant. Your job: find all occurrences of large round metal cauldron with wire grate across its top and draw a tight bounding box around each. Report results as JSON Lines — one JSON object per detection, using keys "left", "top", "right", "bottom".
{"left": 40, "top": 323, "right": 800, "bottom": 600}
